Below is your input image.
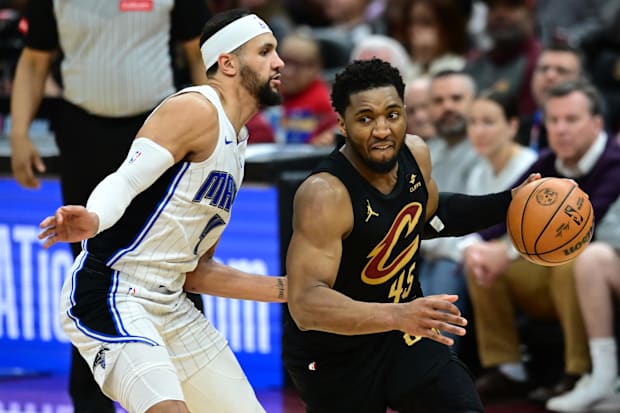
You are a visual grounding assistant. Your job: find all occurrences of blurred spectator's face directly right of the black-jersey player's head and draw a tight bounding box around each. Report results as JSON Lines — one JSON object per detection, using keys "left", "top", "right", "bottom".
{"left": 405, "top": 77, "right": 437, "bottom": 141}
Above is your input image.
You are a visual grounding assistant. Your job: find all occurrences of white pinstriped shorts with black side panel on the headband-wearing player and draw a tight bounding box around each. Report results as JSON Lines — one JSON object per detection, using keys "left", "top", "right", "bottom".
{"left": 61, "top": 254, "right": 264, "bottom": 413}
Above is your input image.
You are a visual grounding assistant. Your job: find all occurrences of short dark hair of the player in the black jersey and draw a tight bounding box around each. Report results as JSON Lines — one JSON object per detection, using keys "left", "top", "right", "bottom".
{"left": 331, "top": 58, "right": 405, "bottom": 116}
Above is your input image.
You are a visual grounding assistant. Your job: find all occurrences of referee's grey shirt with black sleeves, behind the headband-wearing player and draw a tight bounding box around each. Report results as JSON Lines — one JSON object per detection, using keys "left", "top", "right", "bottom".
{"left": 26, "top": 0, "right": 208, "bottom": 117}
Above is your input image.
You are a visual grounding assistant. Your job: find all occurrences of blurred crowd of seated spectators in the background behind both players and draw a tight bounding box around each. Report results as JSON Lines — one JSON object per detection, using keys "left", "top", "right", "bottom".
{"left": 0, "top": 0, "right": 620, "bottom": 411}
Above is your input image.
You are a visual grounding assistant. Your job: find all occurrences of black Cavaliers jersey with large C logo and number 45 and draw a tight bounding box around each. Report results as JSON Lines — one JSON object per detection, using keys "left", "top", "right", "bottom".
{"left": 284, "top": 145, "right": 428, "bottom": 355}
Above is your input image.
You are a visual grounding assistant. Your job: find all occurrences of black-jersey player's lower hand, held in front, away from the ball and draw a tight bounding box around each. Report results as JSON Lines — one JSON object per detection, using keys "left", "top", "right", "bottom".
{"left": 399, "top": 294, "right": 467, "bottom": 346}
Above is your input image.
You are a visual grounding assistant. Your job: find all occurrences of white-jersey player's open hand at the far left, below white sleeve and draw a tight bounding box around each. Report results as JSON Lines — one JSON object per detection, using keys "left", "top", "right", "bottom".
{"left": 38, "top": 205, "right": 99, "bottom": 248}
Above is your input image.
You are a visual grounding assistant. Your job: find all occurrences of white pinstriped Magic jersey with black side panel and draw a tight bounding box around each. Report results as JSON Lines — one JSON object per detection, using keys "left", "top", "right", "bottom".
{"left": 84, "top": 86, "right": 247, "bottom": 301}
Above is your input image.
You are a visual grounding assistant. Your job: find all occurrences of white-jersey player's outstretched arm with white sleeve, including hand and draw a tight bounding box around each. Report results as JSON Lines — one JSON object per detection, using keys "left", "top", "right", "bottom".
{"left": 39, "top": 93, "right": 218, "bottom": 248}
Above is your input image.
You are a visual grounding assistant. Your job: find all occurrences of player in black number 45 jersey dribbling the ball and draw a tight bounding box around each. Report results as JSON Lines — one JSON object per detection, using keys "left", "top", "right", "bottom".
{"left": 283, "top": 59, "right": 540, "bottom": 413}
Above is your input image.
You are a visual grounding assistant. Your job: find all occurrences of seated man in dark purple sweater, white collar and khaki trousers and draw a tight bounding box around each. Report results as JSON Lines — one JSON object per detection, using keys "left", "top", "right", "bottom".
{"left": 464, "top": 81, "right": 620, "bottom": 402}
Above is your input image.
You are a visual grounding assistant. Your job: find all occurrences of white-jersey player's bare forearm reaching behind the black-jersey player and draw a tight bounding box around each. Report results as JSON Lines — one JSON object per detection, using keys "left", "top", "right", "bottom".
{"left": 184, "top": 247, "right": 288, "bottom": 303}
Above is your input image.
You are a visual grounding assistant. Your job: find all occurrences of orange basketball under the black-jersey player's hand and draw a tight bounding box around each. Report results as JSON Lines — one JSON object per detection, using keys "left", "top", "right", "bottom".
{"left": 506, "top": 178, "right": 594, "bottom": 267}
